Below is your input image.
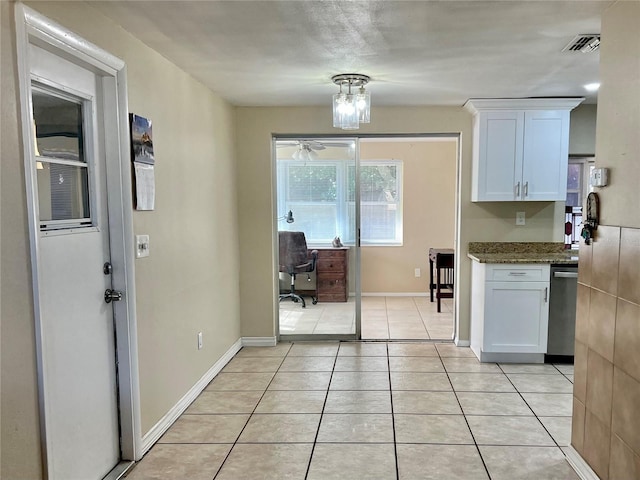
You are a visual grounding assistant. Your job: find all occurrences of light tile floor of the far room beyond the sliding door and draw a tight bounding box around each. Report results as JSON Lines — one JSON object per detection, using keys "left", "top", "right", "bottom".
{"left": 280, "top": 296, "right": 453, "bottom": 340}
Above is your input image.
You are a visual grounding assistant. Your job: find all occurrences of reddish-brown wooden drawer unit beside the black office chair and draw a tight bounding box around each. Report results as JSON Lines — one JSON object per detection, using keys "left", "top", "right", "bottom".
{"left": 315, "top": 247, "right": 349, "bottom": 302}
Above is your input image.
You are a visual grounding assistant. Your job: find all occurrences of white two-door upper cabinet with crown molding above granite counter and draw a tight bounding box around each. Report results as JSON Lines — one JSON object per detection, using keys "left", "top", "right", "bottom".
{"left": 465, "top": 98, "right": 584, "bottom": 202}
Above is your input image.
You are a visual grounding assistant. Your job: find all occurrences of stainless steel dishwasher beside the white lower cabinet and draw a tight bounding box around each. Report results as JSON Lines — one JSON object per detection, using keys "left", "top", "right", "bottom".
{"left": 547, "top": 265, "right": 578, "bottom": 361}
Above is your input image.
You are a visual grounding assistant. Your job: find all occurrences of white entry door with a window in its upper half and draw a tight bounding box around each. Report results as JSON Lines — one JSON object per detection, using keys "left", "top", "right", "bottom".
{"left": 29, "top": 44, "right": 121, "bottom": 480}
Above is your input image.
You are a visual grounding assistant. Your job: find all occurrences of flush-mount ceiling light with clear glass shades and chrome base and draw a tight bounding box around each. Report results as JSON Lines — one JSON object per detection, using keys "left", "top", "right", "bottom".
{"left": 331, "top": 73, "right": 371, "bottom": 130}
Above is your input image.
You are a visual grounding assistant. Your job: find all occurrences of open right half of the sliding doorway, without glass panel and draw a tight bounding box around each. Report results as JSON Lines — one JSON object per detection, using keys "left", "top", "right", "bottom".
{"left": 359, "top": 136, "right": 458, "bottom": 341}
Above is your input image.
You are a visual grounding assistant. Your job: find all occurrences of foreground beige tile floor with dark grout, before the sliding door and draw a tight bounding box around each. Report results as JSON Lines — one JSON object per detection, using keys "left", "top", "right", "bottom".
{"left": 127, "top": 342, "right": 579, "bottom": 480}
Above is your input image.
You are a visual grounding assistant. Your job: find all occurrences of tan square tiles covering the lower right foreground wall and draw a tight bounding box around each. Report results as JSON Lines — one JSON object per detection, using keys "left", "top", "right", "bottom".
{"left": 571, "top": 225, "right": 640, "bottom": 480}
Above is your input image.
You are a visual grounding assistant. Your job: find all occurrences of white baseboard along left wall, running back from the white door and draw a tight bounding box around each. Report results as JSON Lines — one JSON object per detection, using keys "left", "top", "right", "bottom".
{"left": 142, "top": 339, "right": 243, "bottom": 455}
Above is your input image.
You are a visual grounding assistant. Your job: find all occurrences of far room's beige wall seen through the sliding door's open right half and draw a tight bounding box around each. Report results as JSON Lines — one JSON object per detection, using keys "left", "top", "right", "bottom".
{"left": 360, "top": 139, "right": 457, "bottom": 294}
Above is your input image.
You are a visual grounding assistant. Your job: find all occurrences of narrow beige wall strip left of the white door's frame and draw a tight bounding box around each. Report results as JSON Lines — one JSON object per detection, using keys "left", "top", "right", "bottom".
{"left": 0, "top": 2, "right": 41, "bottom": 480}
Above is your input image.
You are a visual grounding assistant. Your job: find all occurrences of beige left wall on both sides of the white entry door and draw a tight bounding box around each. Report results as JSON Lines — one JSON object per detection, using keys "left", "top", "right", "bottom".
{"left": 1, "top": 2, "right": 240, "bottom": 480}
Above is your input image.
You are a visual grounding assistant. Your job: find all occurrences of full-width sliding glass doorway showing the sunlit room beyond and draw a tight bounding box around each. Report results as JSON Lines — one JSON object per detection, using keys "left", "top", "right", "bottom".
{"left": 274, "top": 134, "right": 459, "bottom": 341}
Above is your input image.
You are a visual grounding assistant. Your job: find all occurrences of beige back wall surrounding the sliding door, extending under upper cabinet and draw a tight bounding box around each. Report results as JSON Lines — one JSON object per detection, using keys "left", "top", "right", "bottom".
{"left": 236, "top": 108, "right": 564, "bottom": 340}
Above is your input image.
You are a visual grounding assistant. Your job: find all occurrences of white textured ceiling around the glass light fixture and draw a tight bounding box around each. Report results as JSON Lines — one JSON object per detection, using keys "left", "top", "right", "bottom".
{"left": 90, "top": 0, "right": 613, "bottom": 107}
